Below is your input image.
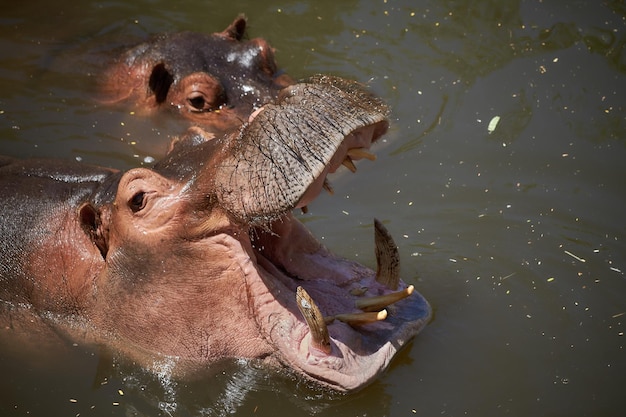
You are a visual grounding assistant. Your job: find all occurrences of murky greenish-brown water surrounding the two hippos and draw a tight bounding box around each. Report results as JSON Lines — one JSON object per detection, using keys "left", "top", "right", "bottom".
{"left": 0, "top": 0, "right": 626, "bottom": 416}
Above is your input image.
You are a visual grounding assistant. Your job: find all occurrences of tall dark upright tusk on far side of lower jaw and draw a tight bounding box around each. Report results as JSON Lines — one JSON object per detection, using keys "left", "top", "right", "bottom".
{"left": 374, "top": 219, "right": 400, "bottom": 291}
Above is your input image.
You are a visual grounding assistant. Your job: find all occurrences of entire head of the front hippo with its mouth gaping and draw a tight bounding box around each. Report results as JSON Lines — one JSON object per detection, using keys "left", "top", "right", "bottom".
{"left": 81, "top": 76, "right": 430, "bottom": 391}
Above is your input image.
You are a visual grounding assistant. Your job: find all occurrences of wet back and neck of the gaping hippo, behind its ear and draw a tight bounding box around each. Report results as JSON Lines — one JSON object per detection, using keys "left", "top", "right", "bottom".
{"left": 0, "top": 157, "right": 118, "bottom": 311}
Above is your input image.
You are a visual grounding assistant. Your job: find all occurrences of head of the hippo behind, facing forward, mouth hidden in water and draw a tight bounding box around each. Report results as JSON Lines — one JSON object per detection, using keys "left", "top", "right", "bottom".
{"left": 101, "top": 16, "right": 293, "bottom": 135}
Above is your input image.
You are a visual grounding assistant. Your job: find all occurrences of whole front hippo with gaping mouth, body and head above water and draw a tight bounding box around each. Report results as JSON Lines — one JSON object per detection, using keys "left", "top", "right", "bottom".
{"left": 0, "top": 76, "right": 430, "bottom": 391}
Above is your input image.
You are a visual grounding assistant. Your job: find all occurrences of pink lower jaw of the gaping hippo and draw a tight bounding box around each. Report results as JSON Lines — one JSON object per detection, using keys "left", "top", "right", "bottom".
{"left": 247, "top": 214, "right": 430, "bottom": 391}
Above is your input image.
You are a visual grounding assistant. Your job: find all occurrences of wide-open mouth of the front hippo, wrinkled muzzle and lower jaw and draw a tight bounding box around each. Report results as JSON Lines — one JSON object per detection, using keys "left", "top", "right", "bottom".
{"left": 207, "top": 76, "right": 430, "bottom": 390}
